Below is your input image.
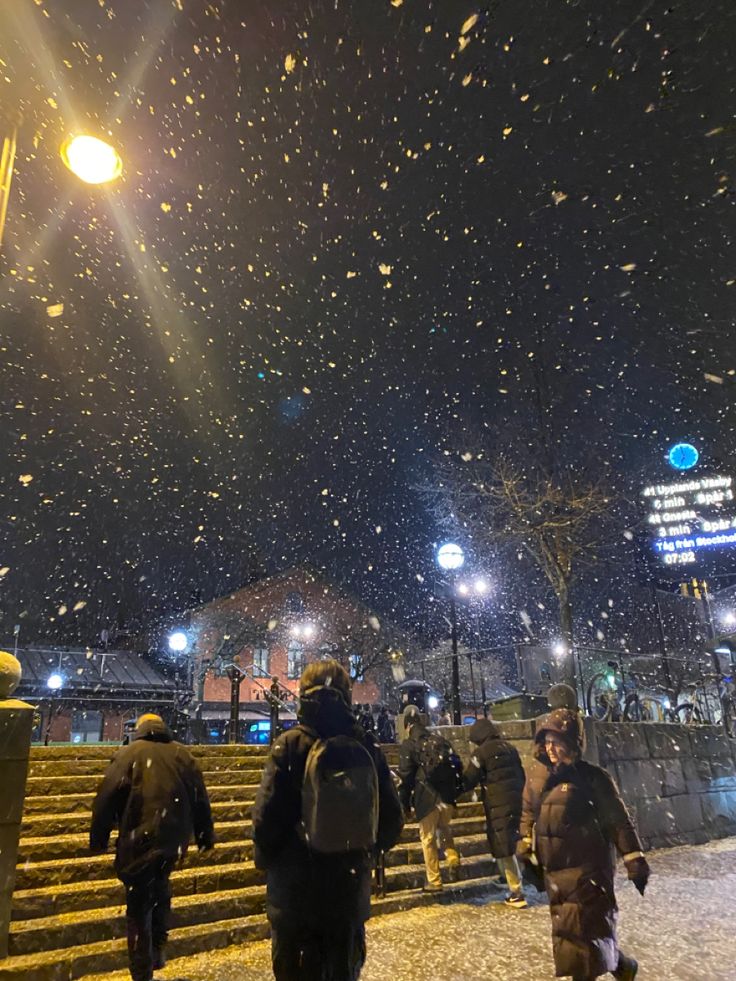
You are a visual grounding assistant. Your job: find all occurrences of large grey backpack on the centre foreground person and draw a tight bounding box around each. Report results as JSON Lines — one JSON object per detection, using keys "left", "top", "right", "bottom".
{"left": 300, "top": 736, "right": 378, "bottom": 855}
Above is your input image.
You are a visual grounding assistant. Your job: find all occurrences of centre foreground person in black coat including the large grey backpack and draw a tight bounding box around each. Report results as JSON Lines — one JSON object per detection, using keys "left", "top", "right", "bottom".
{"left": 253, "top": 660, "right": 404, "bottom": 981}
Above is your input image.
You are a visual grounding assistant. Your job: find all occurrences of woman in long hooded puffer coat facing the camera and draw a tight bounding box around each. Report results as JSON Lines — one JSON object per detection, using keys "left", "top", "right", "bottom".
{"left": 524, "top": 709, "right": 649, "bottom": 981}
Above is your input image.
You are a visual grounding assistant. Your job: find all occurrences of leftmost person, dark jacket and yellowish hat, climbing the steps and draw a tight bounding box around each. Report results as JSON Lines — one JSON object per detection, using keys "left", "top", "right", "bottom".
{"left": 89, "top": 714, "right": 215, "bottom": 981}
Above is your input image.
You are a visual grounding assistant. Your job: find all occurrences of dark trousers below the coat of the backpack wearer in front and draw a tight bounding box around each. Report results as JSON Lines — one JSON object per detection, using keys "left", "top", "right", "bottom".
{"left": 271, "top": 921, "right": 365, "bottom": 981}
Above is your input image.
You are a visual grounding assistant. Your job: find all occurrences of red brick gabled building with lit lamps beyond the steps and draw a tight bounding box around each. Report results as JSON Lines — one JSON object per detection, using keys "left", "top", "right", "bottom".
{"left": 187, "top": 567, "right": 401, "bottom": 738}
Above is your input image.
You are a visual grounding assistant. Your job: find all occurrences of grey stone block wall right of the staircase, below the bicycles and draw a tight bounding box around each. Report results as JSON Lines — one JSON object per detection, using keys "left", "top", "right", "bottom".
{"left": 443, "top": 719, "right": 736, "bottom": 848}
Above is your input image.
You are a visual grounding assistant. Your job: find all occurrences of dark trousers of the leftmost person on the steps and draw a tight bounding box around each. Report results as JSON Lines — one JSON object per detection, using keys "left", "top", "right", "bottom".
{"left": 121, "top": 859, "right": 175, "bottom": 981}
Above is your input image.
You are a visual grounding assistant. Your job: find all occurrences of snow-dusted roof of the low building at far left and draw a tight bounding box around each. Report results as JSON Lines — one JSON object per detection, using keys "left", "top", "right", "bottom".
{"left": 17, "top": 648, "right": 174, "bottom": 697}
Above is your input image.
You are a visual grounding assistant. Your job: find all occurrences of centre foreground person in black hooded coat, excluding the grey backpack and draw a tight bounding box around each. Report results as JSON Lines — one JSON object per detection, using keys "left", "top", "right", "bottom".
{"left": 253, "top": 660, "right": 403, "bottom": 981}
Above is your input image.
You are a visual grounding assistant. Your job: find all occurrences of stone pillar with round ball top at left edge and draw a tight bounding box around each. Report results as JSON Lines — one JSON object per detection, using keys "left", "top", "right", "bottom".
{"left": 0, "top": 651, "right": 33, "bottom": 957}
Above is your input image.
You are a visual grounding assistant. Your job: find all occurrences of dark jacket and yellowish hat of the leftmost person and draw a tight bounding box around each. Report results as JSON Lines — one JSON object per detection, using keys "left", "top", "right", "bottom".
{"left": 90, "top": 720, "right": 215, "bottom": 878}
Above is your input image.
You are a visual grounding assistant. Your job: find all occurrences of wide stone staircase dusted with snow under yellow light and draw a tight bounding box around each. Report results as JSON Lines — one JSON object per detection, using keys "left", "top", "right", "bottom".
{"left": 0, "top": 746, "right": 494, "bottom": 981}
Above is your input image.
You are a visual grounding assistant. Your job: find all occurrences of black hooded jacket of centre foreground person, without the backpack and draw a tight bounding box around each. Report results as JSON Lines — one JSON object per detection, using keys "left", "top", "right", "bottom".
{"left": 253, "top": 689, "right": 403, "bottom": 928}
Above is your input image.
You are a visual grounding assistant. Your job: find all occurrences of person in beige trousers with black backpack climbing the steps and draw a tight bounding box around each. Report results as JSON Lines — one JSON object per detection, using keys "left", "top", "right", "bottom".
{"left": 399, "top": 711, "right": 463, "bottom": 892}
